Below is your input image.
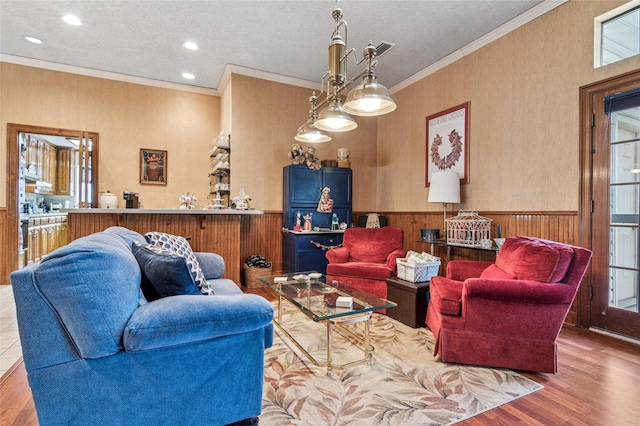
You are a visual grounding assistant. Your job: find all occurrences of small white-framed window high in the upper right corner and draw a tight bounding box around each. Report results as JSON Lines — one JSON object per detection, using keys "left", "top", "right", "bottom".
{"left": 594, "top": 0, "right": 640, "bottom": 68}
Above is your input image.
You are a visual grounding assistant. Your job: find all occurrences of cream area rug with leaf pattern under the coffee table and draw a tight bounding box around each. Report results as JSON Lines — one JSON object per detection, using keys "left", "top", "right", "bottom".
{"left": 260, "top": 302, "right": 542, "bottom": 426}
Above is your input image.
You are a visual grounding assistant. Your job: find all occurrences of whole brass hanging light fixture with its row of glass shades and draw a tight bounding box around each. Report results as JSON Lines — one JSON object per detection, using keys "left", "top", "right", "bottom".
{"left": 295, "top": 0, "right": 396, "bottom": 142}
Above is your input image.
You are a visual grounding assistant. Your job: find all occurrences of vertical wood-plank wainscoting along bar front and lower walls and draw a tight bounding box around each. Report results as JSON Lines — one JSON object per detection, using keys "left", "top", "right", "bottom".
{"left": 0, "top": 210, "right": 588, "bottom": 324}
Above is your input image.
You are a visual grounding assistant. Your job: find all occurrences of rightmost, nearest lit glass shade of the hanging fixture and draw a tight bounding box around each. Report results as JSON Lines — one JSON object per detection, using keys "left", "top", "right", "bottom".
{"left": 344, "top": 75, "right": 396, "bottom": 116}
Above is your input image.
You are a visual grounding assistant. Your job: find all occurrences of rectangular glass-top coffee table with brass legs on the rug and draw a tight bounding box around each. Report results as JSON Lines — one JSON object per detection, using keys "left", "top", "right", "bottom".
{"left": 258, "top": 271, "right": 397, "bottom": 376}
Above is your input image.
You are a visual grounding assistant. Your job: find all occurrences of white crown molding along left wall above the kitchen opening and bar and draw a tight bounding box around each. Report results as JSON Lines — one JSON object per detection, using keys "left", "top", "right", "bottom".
{"left": 0, "top": 54, "right": 220, "bottom": 96}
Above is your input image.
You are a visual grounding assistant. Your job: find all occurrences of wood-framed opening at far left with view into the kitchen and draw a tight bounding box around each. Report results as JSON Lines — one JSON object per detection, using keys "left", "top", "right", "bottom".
{"left": 5, "top": 124, "right": 98, "bottom": 272}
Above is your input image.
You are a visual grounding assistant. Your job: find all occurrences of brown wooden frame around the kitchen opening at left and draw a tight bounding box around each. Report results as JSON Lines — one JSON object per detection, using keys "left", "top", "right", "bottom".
{"left": 5, "top": 123, "right": 99, "bottom": 273}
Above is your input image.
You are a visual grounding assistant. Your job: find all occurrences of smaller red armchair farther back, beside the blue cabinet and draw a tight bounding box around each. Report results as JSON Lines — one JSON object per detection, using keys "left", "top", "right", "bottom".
{"left": 326, "top": 226, "right": 404, "bottom": 299}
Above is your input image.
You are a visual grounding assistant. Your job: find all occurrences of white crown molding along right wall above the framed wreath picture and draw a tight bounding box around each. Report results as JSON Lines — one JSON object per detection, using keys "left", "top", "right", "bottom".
{"left": 389, "top": 0, "right": 569, "bottom": 93}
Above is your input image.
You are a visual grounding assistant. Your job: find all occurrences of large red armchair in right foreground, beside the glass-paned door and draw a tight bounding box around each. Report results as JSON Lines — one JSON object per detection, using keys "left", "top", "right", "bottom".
{"left": 426, "top": 237, "right": 591, "bottom": 373}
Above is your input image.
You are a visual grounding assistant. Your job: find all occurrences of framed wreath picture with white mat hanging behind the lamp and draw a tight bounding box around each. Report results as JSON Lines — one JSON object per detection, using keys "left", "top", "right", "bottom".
{"left": 425, "top": 102, "right": 469, "bottom": 186}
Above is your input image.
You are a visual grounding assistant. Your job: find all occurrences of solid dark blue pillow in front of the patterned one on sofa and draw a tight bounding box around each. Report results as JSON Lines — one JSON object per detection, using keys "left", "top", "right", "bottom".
{"left": 131, "top": 241, "right": 202, "bottom": 302}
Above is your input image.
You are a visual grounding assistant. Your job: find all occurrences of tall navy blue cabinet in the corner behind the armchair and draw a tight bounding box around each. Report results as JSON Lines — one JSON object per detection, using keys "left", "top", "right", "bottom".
{"left": 282, "top": 165, "right": 352, "bottom": 274}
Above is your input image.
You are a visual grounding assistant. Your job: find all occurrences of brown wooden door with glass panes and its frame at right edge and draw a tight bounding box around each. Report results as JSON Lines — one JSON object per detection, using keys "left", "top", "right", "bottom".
{"left": 579, "top": 71, "right": 640, "bottom": 339}
